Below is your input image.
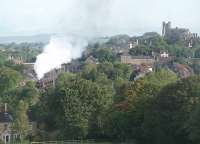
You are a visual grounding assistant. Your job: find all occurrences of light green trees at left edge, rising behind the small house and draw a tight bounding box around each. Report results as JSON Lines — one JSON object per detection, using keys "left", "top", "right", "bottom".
{"left": 0, "top": 65, "right": 40, "bottom": 140}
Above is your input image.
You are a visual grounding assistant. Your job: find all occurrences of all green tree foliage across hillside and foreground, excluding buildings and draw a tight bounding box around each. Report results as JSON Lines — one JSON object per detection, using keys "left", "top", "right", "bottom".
{"left": 0, "top": 33, "right": 200, "bottom": 144}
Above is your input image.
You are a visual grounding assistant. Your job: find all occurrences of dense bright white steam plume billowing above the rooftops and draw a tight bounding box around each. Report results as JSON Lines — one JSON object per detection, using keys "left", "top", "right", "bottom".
{"left": 34, "top": 36, "right": 87, "bottom": 79}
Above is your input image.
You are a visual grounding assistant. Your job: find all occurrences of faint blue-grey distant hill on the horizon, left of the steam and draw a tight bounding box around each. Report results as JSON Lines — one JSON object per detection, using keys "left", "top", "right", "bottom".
{"left": 0, "top": 34, "right": 51, "bottom": 44}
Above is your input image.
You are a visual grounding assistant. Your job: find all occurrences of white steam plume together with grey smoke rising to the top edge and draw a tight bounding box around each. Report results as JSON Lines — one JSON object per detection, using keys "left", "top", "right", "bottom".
{"left": 34, "top": 0, "right": 110, "bottom": 79}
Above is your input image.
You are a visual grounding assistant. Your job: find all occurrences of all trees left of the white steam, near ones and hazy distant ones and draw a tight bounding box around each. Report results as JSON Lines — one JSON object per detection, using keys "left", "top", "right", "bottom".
{"left": 0, "top": 43, "right": 43, "bottom": 141}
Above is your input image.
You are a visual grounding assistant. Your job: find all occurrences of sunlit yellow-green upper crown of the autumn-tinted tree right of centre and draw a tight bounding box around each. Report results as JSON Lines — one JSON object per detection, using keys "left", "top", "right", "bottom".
{"left": 127, "top": 69, "right": 177, "bottom": 101}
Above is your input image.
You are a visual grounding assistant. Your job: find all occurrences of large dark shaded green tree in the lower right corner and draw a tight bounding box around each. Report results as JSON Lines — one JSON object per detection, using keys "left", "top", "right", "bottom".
{"left": 143, "top": 76, "right": 200, "bottom": 144}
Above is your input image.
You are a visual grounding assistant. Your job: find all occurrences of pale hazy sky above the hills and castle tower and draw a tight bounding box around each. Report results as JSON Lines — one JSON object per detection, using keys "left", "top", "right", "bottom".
{"left": 0, "top": 0, "right": 200, "bottom": 36}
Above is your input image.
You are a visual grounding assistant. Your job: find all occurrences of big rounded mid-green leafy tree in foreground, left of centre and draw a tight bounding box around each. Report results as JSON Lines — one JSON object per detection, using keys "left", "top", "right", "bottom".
{"left": 48, "top": 76, "right": 112, "bottom": 139}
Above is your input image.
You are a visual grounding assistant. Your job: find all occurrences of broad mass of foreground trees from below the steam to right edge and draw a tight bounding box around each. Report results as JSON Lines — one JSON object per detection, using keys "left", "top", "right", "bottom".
{"left": 30, "top": 63, "right": 200, "bottom": 144}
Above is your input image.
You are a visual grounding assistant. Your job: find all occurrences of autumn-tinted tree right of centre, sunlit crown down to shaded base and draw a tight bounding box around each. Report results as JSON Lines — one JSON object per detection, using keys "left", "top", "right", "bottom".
{"left": 105, "top": 69, "right": 177, "bottom": 143}
